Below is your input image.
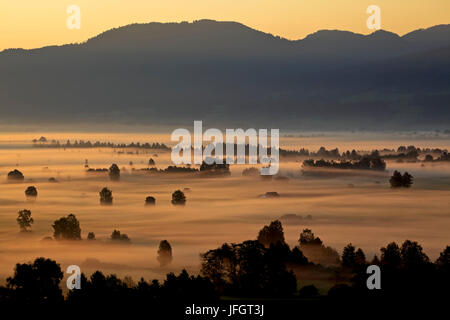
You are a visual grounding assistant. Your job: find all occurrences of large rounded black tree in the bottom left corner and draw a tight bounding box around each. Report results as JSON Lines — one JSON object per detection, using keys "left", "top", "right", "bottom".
{"left": 6, "top": 258, "right": 64, "bottom": 305}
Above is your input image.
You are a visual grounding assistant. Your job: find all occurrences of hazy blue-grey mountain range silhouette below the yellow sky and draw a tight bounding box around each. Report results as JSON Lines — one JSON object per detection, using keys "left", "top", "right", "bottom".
{"left": 0, "top": 20, "right": 450, "bottom": 130}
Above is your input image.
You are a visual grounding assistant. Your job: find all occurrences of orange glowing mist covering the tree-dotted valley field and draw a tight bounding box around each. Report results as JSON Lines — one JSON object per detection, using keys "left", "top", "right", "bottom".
{"left": 0, "top": 133, "right": 450, "bottom": 290}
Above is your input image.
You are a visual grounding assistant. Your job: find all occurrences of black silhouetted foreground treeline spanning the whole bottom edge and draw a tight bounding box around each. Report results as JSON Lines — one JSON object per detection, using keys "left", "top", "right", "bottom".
{"left": 0, "top": 221, "right": 450, "bottom": 312}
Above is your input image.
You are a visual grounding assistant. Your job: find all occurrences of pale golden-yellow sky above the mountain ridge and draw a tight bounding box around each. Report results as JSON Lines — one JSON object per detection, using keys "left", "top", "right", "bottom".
{"left": 0, "top": 0, "right": 450, "bottom": 50}
